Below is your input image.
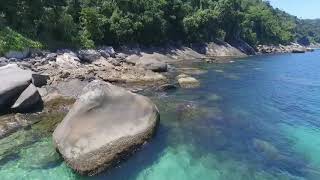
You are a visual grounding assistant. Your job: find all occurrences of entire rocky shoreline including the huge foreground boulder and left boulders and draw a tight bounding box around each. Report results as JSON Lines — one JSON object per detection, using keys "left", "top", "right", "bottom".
{"left": 0, "top": 42, "right": 318, "bottom": 175}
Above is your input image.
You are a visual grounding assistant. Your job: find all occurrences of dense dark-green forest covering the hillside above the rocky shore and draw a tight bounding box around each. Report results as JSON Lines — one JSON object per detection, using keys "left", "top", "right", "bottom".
{"left": 0, "top": 0, "right": 320, "bottom": 53}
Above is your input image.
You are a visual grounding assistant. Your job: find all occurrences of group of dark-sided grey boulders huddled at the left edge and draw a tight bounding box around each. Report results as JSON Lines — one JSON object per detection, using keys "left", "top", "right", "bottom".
{"left": 0, "top": 64, "right": 48, "bottom": 113}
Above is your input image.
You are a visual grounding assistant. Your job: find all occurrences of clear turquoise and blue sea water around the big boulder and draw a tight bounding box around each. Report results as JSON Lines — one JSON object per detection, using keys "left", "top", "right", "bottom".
{"left": 0, "top": 51, "right": 320, "bottom": 180}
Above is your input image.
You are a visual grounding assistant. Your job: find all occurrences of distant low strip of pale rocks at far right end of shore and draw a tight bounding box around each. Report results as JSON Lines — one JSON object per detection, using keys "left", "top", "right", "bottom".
{"left": 257, "top": 43, "right": 313, "bottom": 54}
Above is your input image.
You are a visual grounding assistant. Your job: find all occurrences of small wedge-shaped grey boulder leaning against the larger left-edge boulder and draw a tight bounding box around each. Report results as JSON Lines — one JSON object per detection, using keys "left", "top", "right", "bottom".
{"left": 11, "top": 84, "right": 42, "bottom": 112}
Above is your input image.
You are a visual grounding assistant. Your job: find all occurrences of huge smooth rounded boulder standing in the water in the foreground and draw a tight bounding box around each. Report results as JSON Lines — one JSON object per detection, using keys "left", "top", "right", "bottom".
{"left": 53, "top": 81, "right": 159, "bottom": 175}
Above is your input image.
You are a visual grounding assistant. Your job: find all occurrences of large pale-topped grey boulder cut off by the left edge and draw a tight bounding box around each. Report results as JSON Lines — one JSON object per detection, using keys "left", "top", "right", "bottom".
{"left": 0, "top": 64, "right": 32, "bottom": 112}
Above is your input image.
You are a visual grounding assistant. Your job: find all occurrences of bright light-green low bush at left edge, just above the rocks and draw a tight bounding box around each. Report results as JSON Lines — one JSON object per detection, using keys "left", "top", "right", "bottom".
{"left": 0, "top": 27, "right": 42, "bottom": 55}
